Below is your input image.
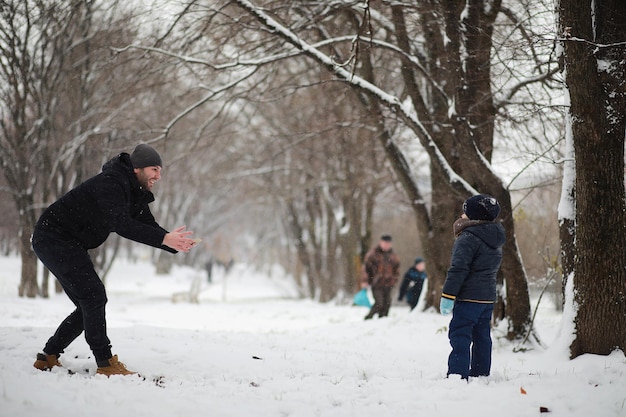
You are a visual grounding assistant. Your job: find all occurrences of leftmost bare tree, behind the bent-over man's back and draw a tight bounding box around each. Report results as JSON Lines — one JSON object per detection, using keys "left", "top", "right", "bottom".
{"left": 0, "top": 1, "right": 96, "bottom": 297}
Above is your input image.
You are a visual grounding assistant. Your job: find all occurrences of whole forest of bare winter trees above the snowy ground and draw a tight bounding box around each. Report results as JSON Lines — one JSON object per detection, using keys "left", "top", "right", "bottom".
{"left": 0, "top": 0, "right": 626, "bottom": 356}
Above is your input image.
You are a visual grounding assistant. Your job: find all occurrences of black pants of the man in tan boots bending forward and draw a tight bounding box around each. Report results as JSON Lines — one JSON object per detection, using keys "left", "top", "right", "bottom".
{"left": 32, "top": 229, "right": 111, "bottom": 362}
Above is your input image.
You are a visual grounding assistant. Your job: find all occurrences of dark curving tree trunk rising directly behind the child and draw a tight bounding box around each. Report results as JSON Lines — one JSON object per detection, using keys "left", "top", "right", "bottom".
{"left": 442, "top": 0, "right": 531, "bottom": 339}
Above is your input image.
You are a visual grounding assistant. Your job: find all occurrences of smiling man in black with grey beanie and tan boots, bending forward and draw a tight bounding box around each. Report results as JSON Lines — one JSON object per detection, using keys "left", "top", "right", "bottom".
{"left": 32, "top": 144, "right": 196, "bottom": 376}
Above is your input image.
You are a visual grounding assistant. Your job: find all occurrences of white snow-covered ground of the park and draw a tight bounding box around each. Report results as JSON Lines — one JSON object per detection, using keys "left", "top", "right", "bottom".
{"left": 0, "top": 254, "right": 626, "bottom": 417}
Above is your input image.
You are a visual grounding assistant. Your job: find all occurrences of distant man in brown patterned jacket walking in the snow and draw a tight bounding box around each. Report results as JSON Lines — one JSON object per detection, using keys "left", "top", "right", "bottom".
{"left": 361, "top": 235, "right": 400, "bottom": 320}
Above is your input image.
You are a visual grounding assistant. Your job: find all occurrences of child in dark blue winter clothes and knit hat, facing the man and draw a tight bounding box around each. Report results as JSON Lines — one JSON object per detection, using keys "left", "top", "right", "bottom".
{"left": 440, "top": 194, "right": 505, "bottom": 379}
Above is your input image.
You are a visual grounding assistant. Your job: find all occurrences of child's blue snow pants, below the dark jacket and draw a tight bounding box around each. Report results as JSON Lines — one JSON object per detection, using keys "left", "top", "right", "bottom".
{"left": 448, "top": 301, "right": 493, "bottom": 379}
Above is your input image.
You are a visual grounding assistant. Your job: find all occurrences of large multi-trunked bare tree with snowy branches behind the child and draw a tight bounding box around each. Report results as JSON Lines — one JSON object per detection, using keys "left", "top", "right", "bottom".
{"left": 116, "top": 0, "right": 555, "bottom": 337}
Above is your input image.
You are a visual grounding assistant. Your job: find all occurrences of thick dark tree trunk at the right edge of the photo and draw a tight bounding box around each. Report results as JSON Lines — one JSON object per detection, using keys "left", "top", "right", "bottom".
{"left": 559, "top": 0, "right": 626, "bottom": 357}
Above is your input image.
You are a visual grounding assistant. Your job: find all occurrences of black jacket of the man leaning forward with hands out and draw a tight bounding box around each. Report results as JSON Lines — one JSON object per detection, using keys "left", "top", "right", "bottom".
{"left": 35, "top": 153, "right": 176, "bottom": 253}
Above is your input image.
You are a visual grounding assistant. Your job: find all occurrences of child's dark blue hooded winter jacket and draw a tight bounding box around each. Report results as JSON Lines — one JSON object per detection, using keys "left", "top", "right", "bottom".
{"left": 442, "top": 219, "right": 505, "bottom": 303}
